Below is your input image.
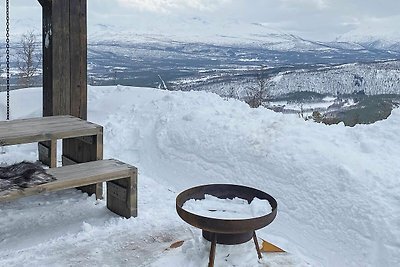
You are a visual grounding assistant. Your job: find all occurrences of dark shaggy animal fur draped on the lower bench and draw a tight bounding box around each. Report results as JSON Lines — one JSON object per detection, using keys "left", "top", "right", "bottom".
{"left": 0, "top": 161, "right": 55, "bottom": 191}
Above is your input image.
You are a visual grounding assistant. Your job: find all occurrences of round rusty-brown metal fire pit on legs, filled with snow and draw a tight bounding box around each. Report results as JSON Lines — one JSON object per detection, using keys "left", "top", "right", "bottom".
{"left": 176, "top": 184, "right": 278, "bottom": 267}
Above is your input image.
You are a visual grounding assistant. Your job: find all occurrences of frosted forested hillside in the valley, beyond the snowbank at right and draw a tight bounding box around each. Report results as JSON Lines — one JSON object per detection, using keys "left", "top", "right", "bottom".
{"left": 199, "top": 61, "right": 400, "bottom": 96}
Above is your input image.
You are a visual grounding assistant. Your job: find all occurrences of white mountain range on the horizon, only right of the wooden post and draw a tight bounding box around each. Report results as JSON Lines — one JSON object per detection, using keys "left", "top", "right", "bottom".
{"left": 88, "top": 17, "right": 400, "bottom": 53}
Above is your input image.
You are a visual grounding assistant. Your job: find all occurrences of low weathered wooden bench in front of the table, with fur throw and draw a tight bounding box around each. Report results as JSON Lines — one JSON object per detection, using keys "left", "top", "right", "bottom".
{"left": 0, "top": 159, "right": 137, "bottom": 218}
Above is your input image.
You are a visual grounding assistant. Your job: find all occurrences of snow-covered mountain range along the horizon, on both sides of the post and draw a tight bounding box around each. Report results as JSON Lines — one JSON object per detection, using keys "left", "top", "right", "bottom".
{"left": 0, "top": 10, "right": 400, "bottom": 52}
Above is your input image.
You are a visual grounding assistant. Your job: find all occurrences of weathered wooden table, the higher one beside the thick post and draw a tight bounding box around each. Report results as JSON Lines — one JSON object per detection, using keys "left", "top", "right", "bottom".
{"left": 0, "top": 115, "right": 103, "bottom": 198}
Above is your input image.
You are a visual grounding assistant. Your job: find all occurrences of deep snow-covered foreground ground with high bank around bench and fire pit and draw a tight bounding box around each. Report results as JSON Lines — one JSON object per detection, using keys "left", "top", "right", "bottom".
{"left": 0, "top": 86, "right": 400, "bottom": 267}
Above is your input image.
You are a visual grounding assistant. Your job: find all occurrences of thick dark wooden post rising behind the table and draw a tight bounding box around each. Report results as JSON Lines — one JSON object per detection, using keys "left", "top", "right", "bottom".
{"left": 38, "top": 0, "right": 103, "bottom": 197}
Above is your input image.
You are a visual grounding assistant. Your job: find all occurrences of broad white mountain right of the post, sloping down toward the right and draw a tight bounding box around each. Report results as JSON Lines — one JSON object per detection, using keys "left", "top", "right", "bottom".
{"left": 89, "top": 17, "right": 398, "bottom": 52}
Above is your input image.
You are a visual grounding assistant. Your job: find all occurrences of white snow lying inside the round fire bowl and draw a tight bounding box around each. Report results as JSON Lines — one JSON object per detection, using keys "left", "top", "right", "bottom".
{"left": 182, "top": 194, "right": 272, "bottom": 220}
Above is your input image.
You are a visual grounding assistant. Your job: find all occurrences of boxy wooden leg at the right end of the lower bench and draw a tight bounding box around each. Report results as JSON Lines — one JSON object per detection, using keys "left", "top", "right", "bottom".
{"left": 107, "top": 167, "right": 137, "bottom": 218}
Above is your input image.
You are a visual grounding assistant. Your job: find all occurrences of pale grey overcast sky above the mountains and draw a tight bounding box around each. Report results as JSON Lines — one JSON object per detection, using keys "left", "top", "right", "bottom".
{"left": 1, "top": 0, "right": 400, "bottom": 41}
